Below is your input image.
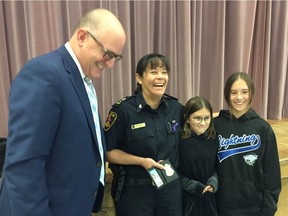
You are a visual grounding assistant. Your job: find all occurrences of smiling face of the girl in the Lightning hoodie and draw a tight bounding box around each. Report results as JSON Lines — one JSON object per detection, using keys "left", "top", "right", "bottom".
{"left": 229, "top": 78, "right": 250, "bottom": 118}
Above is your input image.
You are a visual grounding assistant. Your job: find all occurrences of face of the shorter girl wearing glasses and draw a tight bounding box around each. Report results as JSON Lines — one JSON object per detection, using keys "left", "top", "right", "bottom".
{"left": 187, "top": 108, "right": 211, "bottom": 135}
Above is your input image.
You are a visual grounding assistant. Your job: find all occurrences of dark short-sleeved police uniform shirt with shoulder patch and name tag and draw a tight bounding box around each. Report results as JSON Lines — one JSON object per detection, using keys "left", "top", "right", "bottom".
{"left": 104, "top": 92, "right": 183, "bottom": 177}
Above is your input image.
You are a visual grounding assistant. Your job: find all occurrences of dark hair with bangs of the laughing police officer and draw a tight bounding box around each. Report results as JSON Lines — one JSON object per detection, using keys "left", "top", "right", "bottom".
{"left": 135, "top": 53, "right": 170, "bottom": 94}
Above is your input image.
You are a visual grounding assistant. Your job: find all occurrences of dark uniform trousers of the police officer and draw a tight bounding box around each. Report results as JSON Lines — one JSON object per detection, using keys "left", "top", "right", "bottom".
{"left": 115, "top": 179, "right": 182, "bottom": 216}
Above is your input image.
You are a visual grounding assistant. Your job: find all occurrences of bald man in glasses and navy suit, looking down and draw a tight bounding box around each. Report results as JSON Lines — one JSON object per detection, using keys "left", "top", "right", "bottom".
{"left": 0, "top": 9, "right": 126, "bottom": 216}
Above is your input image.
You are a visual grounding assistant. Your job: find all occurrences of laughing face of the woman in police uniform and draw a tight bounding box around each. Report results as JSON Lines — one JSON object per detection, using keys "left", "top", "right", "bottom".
{"left": 136, "top": 64, "right": 169, "bottom": 102}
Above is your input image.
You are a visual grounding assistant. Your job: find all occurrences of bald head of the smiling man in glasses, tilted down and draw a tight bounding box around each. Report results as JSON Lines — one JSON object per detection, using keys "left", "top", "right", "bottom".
{"left": 69, "top": 9, "right": 126, "bottom": 79}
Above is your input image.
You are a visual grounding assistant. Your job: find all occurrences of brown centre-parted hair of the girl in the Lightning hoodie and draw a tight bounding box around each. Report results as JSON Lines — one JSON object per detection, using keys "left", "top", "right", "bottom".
{"left": 224, "top": 72, "right": 255, "bottom": 108}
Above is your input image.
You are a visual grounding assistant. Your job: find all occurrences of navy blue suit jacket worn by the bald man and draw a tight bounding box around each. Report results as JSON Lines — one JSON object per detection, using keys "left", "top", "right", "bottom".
{"left": 0, "top": 46, "right": 106, "bottom": 216}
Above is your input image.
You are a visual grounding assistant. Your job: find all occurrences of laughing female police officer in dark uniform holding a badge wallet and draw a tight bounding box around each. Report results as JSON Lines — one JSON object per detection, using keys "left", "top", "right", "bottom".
{"left": 104, "top": 54, "right": 183, "bottom": 216}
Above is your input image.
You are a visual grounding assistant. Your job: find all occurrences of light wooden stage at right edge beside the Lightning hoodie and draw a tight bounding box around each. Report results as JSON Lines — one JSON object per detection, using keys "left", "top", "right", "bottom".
{"left": 268, "top": 119, "right": 288, "bottom": 216}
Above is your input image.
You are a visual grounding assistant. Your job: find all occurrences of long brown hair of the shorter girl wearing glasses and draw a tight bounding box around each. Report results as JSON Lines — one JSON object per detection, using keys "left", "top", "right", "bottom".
{"left": 181, "top": 96, "right": 216, "bottom": 139}
